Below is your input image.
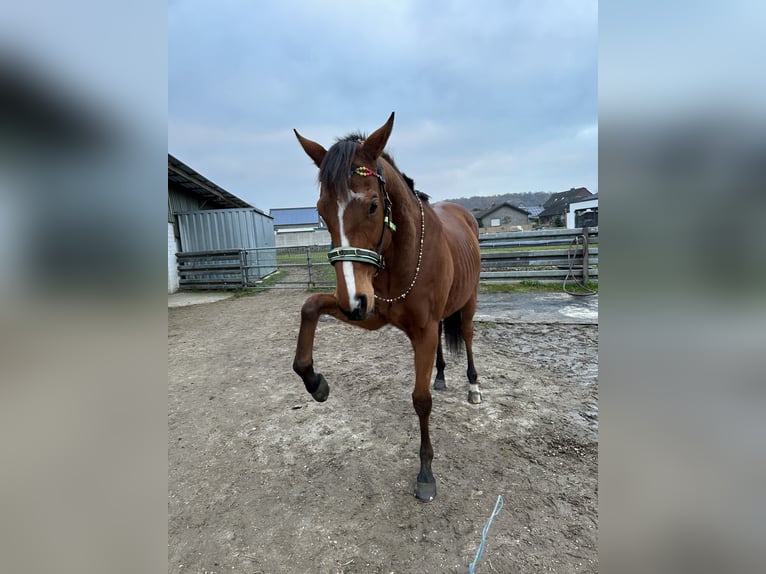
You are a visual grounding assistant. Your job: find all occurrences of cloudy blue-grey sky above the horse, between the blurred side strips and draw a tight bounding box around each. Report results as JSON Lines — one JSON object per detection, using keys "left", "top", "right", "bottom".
{"left": 168, "top": 0, "right": 598, "bottom": 212}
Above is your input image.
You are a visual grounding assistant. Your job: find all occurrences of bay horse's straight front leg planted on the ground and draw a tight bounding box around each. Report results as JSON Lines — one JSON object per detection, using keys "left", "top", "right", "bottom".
{"left": 410, "top": 323, "right": 439, "bottom": 502}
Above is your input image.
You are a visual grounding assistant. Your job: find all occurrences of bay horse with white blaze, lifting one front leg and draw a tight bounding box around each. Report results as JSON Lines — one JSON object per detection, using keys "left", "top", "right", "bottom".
{"left": 293, "top": 113, "right": 481, "bottom": 502}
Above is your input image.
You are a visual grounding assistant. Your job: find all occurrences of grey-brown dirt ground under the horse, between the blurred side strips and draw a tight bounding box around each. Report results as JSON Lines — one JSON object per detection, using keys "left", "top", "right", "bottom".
{"left": 168, "top": 291, "right": 598, "bottom": 574}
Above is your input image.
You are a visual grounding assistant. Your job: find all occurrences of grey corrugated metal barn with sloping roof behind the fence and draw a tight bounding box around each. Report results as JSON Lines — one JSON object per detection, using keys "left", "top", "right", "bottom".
{"left": 168, "top": 154, "right": 276, "bottom": 293}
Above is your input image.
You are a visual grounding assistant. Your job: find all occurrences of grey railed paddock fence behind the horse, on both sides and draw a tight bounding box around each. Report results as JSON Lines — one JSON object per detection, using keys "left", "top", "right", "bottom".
{"left": 176, "top": 227, "right": 598, "bottom": 290}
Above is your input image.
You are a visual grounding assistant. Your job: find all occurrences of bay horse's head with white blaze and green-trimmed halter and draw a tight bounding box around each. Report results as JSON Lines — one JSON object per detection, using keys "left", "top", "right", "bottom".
{"left": 294, "top": 112, "right": 395, "bottom": 320}
